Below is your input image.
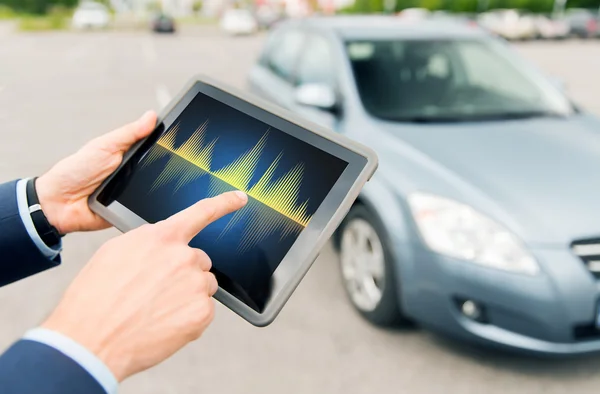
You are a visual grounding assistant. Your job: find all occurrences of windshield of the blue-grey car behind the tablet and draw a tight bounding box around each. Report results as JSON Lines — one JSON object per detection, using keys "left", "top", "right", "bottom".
{"left": 346, "top": 38, "right": 574, "bottom": 121}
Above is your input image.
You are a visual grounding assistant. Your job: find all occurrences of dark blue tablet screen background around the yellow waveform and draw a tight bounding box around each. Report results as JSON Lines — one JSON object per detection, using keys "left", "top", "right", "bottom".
{"left": 114, "top": 93, "right": 347, "bottom": 312}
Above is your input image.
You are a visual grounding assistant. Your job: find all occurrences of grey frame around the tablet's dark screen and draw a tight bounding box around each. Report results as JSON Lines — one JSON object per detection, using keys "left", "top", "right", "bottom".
{"left": 89, "top": 76, "right": 377, "bottom": 327}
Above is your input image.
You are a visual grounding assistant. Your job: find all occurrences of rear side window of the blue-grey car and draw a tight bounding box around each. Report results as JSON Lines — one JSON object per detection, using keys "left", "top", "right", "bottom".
{"left": 263, "top": 30, "right": 305, "bottom": 81}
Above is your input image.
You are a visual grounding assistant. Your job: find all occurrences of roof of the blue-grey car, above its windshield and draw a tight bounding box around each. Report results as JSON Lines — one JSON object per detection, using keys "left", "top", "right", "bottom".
{"left": 287, "top": 16, "right": 487, "bottom": 40}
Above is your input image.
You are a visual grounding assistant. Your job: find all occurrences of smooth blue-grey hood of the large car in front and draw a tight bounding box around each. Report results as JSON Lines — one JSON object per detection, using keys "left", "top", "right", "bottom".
{"left": 376, "top": 115, "right": 600, "bottom": 245}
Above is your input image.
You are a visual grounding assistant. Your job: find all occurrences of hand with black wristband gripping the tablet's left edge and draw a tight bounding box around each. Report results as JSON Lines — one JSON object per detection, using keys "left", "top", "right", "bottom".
{"left": 36, "top": 111, "right": 156, "bottom": 234}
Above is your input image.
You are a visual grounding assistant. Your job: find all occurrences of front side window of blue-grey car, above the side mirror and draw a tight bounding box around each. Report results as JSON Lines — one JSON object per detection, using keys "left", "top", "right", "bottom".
{"left": 296, "top": 36, "right": 335, "bottom": 86}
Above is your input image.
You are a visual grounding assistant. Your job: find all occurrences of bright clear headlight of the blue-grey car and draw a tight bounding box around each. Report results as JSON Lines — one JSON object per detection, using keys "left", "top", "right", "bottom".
{"left": 408, "top": 193, "right": 540, "bottom": 275}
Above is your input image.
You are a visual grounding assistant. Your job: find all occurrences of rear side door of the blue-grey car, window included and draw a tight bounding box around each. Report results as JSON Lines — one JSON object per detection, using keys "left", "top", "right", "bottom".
{"left": 249, "top": 28, "right": 306, "bottom": 109}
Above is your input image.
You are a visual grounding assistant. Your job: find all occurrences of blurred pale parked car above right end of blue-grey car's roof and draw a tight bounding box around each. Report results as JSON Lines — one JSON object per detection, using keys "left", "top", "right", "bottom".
{"left": 478, "top": 10, "right": 537, "bottom": 40}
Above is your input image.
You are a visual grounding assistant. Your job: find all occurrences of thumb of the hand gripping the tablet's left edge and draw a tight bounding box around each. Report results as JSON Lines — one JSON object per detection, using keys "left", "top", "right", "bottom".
{"left": 99, "top": 111, "right": 156, "bottom": 153}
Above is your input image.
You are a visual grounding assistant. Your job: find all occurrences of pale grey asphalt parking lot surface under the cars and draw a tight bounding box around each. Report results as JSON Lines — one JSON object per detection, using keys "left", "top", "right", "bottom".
{"left": 0, "top": 29, "right": 600, "bottom": 394}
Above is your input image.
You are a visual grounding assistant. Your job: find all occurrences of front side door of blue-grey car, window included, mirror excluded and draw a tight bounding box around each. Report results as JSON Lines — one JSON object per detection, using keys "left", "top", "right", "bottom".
{"left": 290, "top": 33, "right": 341, "bottom": 130}
